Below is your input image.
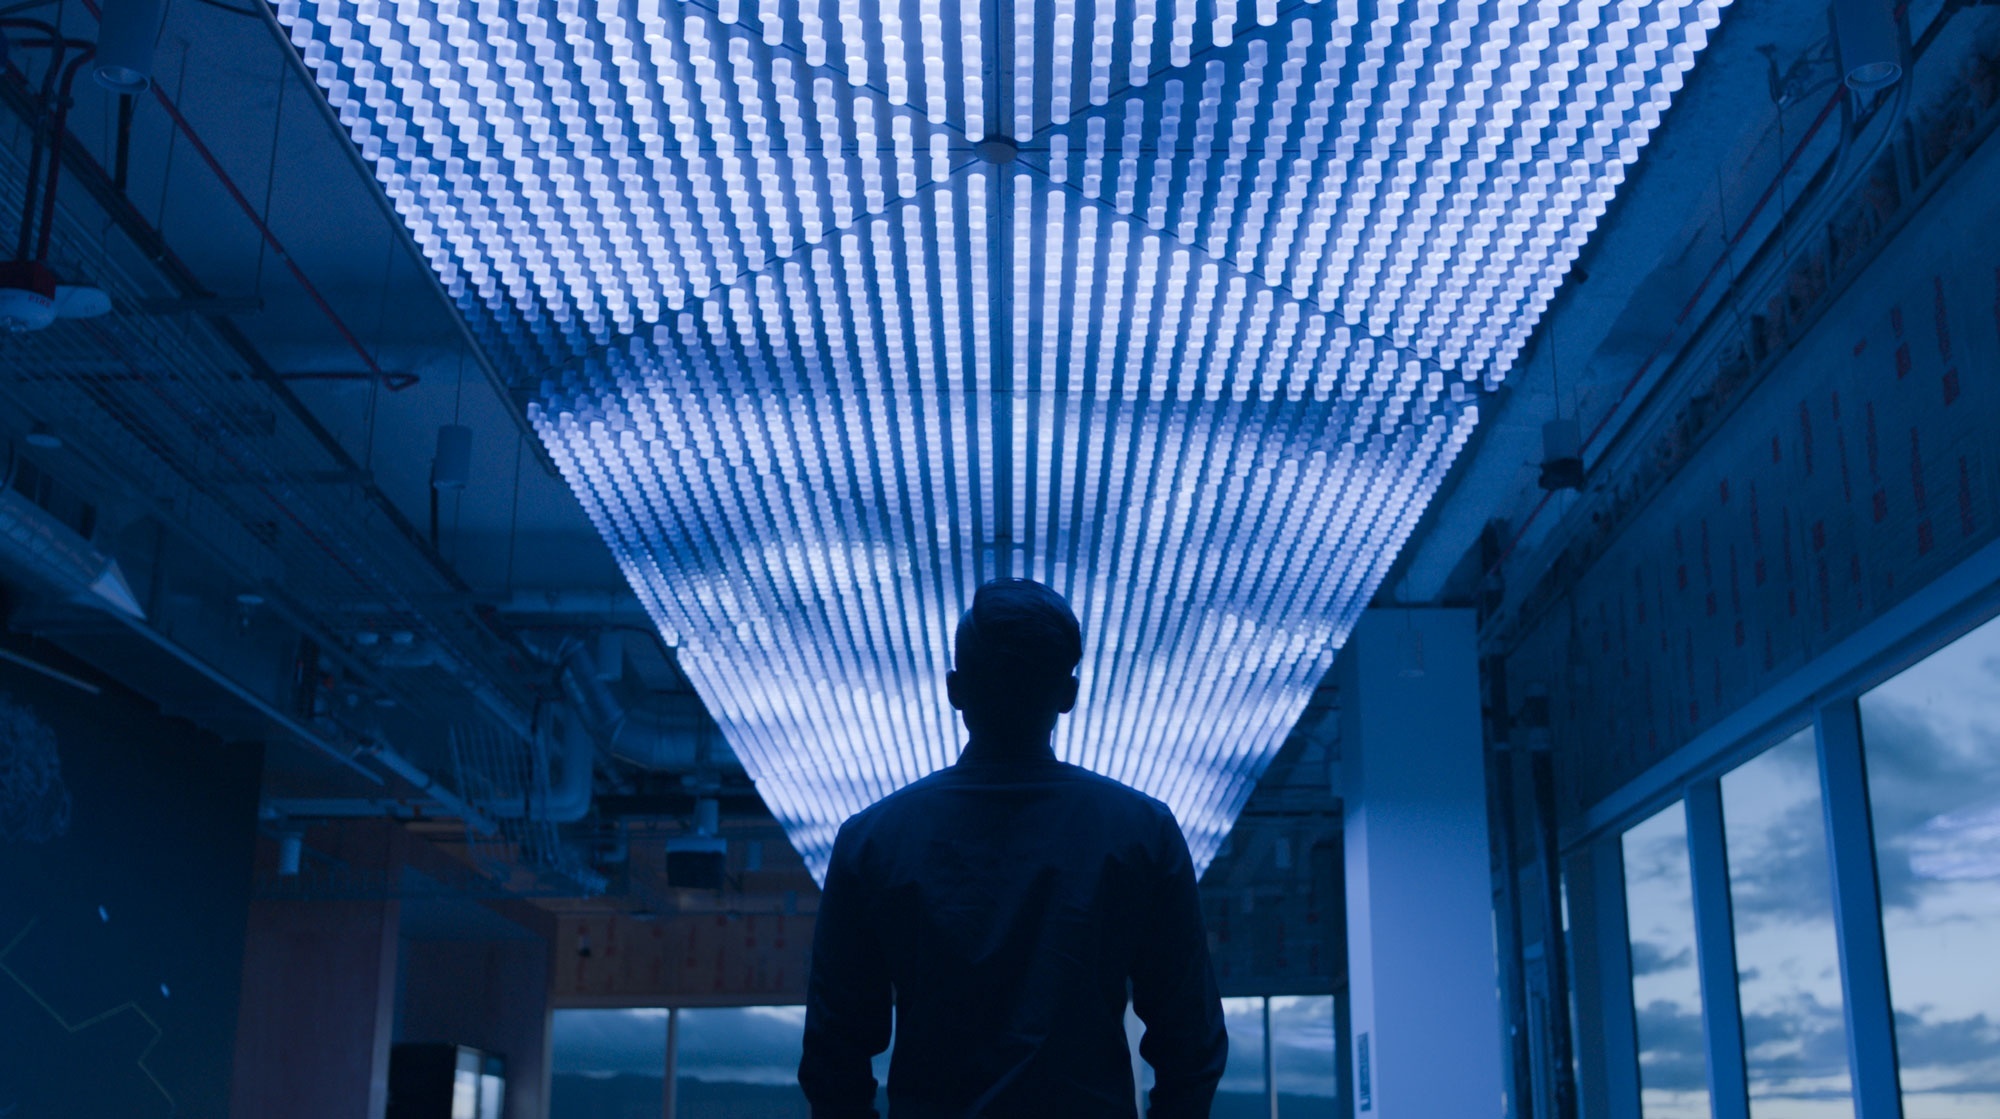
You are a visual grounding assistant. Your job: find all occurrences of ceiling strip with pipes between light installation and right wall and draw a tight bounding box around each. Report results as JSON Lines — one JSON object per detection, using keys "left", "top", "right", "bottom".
{"left": 1390, "top": 0, "right": 2000, "bottom": 619}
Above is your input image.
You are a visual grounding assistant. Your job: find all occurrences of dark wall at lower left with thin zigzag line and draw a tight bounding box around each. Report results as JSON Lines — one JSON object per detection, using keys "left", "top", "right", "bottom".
{"left": 0, "top": 649, "right": 262, "bottom": 1119}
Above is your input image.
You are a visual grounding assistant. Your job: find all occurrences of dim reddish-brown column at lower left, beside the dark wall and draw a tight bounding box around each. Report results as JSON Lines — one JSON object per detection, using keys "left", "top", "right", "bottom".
{"left": 230, "top": 823, "right": 402, "bottom": 1119}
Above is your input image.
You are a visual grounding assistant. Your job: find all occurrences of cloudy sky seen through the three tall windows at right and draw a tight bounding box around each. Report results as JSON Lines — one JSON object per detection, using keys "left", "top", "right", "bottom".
{"left": 1624, "top": 621, "right": 2000, "bottom": 1119}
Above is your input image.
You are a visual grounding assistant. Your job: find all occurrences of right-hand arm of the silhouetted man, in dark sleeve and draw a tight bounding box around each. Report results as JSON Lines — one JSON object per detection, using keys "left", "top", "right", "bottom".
{"left": 1132, "top": 817, "right": 1230, "bottom": 1119}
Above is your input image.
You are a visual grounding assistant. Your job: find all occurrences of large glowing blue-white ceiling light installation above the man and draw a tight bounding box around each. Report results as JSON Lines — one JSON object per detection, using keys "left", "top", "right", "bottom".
{"left": 278, "top": 0, "right": 1720, "bottom": 869}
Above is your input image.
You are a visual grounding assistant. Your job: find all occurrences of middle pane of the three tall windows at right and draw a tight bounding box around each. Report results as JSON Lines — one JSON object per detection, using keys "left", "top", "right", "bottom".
{"left": 1722, "top": 727, "right": 1854, "bottom": 1119}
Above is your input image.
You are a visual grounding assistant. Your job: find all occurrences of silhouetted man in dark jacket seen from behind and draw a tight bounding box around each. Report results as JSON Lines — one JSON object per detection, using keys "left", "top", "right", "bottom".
{"left": 798, "top": 579, "right": 1228, "bottom": 1119}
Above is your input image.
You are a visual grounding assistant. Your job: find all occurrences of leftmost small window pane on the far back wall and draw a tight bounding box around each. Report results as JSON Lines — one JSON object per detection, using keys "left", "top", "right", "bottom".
{"left": 548, "top": 1009, "right": 666, "bottom": 1119}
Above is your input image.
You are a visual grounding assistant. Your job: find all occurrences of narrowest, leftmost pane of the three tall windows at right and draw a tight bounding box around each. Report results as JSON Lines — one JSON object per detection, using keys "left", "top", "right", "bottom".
{"left": 1624, "top": 801, "right": 1710, "bottom": 1119}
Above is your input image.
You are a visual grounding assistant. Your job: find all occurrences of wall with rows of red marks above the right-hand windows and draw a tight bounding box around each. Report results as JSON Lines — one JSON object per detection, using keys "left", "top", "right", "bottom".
{"left": 1508, "top": 120, "right": 2000, "bottom": 815}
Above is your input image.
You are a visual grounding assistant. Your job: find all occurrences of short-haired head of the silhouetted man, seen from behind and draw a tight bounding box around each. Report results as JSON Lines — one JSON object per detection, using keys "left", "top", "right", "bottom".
{"left": 944, "top": 579, "right": 1084, "bottom": 739}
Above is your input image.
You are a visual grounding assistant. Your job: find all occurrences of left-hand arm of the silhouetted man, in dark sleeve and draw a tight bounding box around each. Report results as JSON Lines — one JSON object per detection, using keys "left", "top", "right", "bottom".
{"left": 798, "top": 821, "right": 890, "bottom": 1119}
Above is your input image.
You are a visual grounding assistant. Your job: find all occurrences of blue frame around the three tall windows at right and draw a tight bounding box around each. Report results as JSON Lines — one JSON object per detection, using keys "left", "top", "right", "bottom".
{"left": 1558, "top": 542, "right": 2000, "bottom": 1119}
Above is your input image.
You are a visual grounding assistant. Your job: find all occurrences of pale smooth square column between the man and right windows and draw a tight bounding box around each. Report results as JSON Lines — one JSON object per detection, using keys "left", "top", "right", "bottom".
{"left": 1338, "top": 609, "right": 1504, "bottom": 1119}
